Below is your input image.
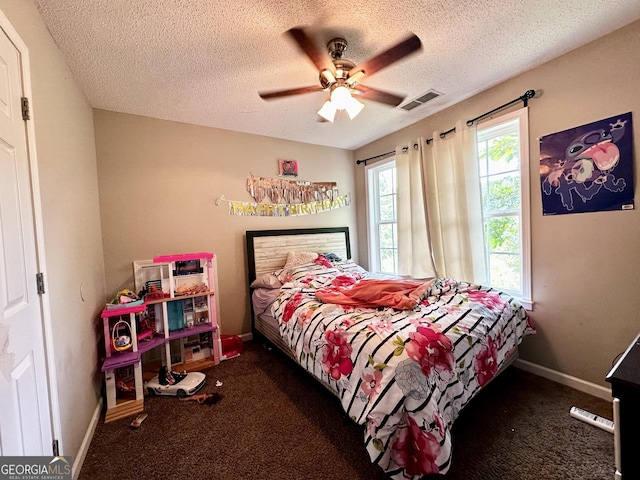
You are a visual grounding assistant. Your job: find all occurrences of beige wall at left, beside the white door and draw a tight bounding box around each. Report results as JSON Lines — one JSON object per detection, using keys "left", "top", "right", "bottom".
{"left": 0, "top": 0, "right": 105, "bottom": 460}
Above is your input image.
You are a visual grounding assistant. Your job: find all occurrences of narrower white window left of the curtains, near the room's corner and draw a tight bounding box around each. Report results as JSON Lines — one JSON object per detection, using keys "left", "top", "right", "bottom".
{"left": 365, "top": 157, "right": 398, "bottom": 274}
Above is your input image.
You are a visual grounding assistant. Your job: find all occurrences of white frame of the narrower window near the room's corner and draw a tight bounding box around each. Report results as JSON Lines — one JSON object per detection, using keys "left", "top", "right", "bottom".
{"left": 364, "top": 155, "right": 398, "bottom": 273}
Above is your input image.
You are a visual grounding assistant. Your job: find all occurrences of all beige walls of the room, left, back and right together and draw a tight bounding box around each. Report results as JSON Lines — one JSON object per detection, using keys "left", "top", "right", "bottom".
{"left": 0, "top": 0, "right": 640, "bottom": 464}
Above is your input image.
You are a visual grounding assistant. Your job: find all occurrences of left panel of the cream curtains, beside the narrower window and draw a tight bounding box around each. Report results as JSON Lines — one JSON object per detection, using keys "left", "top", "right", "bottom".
{"left": 396, "top": 138, "right": 437, "bottom": 278}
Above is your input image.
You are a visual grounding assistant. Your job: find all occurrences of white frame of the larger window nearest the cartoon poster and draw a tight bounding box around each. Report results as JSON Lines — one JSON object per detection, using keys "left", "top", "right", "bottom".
{"left": 476, "top": 107, "right": 533, "bottom": 310}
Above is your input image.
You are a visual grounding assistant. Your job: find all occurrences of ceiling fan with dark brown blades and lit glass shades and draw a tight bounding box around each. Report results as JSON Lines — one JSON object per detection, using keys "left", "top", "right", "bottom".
{"left": 259, "top": 28, "right": 422, "bottom": 122}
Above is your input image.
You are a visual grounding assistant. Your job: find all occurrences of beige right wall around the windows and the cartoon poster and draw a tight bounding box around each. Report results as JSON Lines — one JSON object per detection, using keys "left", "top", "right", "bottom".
{"left": 356, "top": 22, "right": 640, "bottom": 386}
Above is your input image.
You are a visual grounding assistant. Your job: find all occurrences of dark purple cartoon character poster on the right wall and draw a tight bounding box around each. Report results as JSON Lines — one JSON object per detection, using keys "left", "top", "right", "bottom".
{"left": 540, "top": 112, "right": 634, "bottom": 215}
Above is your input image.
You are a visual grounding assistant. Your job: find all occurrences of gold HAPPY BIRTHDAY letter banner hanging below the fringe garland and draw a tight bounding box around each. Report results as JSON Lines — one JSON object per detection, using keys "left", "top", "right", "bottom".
{"left": 219, "top": 194, "right": 351, "bottom": 217}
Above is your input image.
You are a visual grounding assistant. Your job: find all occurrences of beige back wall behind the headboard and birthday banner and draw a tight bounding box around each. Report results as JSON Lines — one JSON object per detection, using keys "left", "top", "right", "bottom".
{"left": 94, "top": 110, "right": 357, "bottom": 334}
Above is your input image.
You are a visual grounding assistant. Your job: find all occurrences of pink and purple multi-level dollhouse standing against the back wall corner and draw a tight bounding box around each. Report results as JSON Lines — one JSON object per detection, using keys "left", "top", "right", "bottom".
{"left": 101, "top": 252, "right": 222, "bottom": 422}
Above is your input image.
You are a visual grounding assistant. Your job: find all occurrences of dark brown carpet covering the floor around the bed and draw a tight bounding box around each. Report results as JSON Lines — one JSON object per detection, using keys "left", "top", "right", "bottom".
{"left": 79, "top": 342, "right": 615, "bottom": 480}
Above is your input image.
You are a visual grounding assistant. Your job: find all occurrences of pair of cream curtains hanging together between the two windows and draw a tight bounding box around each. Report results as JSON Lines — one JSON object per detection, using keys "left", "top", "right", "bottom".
{"left": 396, "top": 121, "right": 486, "bottom": 283}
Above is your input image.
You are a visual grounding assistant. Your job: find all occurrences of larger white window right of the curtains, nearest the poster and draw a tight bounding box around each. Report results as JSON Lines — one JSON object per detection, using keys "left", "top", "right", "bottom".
{"left": 477, "top": 108, "right": 531, "bottom": 308}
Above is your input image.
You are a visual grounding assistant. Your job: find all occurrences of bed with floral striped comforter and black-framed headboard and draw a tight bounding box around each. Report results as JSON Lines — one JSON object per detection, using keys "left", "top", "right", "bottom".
{"left": 246, "top": 227, "right": 535, "bottom": 479}
